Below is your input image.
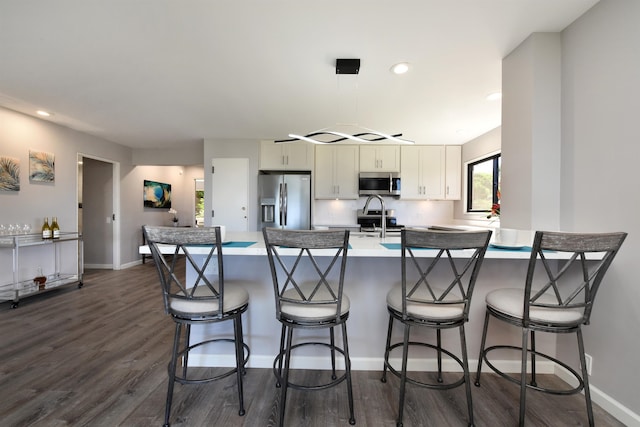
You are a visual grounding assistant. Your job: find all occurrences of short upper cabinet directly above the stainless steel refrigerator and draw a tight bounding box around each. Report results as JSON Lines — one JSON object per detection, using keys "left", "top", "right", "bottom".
{"left": 260, "top": 141, "right": 313, "bottom": 171}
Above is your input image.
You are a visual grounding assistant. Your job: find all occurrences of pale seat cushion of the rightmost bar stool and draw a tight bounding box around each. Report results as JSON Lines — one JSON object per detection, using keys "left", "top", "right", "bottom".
{"left": 486, "top": 288, "right": 583, "bottom": 324}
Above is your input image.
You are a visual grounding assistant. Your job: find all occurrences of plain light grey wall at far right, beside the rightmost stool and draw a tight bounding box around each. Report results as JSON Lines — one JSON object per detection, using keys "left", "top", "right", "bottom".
{"left": 559, "top": 0, "right": 640, "bottom": 413}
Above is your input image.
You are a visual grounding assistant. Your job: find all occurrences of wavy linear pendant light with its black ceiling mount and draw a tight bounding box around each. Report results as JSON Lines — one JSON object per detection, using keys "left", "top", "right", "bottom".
{"left": 274, "top": 58, "right": 414, "bottom": 144}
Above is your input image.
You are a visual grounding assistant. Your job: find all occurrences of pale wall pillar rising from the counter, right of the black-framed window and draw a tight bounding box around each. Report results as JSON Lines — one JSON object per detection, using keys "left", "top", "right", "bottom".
{"left": 500, "top": 33, "right": 561, "bottom": 230}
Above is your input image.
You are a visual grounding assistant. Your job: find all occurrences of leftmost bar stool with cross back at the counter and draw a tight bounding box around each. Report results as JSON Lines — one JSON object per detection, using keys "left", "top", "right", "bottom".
{"left": 143, "top": 225, "right": 249, "bottom": 426}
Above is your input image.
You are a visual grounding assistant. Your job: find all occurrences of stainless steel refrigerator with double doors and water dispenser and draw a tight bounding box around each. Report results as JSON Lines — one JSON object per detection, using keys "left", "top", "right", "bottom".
{"left": 258, "top": 171, "right": 311, "bottom": 230}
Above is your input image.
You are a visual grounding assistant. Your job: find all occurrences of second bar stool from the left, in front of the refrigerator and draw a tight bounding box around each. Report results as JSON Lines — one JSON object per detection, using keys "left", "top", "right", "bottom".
{"left": 263, "top": 228, "right": 356, "bottom": 426}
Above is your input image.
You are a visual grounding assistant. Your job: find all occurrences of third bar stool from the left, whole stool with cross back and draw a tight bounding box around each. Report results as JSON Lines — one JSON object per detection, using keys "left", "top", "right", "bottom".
{"left": 381, "top": 229, "right": 491, "bottom": 426}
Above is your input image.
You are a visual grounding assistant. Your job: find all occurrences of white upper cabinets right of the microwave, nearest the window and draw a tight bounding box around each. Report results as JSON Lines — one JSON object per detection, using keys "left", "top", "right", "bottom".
{"left": 400, "top": 145, "right": 461, "bottom": 200}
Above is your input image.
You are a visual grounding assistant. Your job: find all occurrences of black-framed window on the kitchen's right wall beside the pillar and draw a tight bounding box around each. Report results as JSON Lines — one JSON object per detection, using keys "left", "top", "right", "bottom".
{"left": 467, "top": 154, "right": 501, "bottom": 212}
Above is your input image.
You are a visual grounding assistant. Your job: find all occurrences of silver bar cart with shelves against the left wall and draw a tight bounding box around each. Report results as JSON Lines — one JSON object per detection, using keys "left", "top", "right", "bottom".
{"left": 0, "top": 232, "right": 84, "bottom": 308}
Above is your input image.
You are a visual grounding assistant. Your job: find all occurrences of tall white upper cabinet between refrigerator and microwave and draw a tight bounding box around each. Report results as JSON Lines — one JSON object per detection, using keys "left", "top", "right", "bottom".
{"left": 314, "top": 145, "right": 359, "bottom": 199}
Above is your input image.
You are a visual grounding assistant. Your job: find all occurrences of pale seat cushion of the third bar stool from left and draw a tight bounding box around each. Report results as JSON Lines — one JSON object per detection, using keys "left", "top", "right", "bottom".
{"left": 387, "top": 285, "right": 464, "bottom": 320}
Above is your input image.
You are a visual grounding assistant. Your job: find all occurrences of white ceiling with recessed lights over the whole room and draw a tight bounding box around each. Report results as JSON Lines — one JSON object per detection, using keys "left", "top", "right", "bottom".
{"left": 0, "top": 0, "right": 597, "bottom": 148}
